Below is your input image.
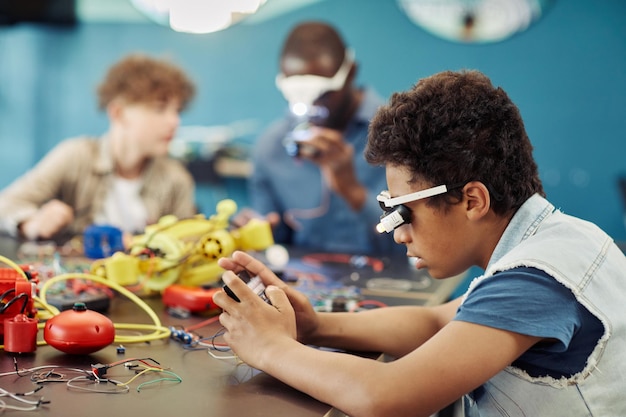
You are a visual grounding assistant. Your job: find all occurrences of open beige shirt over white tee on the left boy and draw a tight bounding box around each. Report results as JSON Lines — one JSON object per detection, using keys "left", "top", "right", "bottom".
{"left": 0, "top": 137, "right": 196, "bottom": 236}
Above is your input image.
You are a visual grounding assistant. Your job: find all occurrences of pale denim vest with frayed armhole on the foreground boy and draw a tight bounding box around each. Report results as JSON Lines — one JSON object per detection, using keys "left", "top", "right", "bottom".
{"left": 464, "top": 195, "right": 626, "bottom": 417}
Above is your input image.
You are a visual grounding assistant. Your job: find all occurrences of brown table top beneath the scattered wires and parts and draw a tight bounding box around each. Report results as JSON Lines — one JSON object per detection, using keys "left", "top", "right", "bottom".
{"left": 0, "top": 236, "right": 463, "bottom": 417}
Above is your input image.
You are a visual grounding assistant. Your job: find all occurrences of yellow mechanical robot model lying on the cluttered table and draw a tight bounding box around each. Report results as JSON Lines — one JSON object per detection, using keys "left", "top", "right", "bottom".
{"left": 91, "top": 199, "right": 274, "bottom": 292}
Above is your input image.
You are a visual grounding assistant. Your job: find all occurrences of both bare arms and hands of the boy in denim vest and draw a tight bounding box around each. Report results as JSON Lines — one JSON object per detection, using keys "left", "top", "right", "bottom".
{"left": 214, "top": 252, "right": 540, "bottom": 417}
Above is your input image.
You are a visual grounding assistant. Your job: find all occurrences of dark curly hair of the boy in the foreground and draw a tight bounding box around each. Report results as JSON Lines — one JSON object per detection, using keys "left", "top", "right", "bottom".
{"left": 365, "top": 70, "right": 545, "bottom": 215}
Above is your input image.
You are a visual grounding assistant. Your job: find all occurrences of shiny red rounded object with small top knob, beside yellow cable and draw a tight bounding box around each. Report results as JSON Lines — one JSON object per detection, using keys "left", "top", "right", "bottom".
{"left": 43, "top": 303, "right": 115, "bottom": 355}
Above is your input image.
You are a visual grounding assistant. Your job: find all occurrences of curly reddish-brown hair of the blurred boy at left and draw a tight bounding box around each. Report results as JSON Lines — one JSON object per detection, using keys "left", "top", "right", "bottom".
{"left": 97, "top": 53, "right": 195, "bottom": 110}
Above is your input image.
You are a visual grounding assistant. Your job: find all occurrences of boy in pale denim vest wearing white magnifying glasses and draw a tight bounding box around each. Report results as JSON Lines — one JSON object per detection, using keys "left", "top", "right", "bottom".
{"left": 215, "top": 71, "right": 626, "bottom": 417}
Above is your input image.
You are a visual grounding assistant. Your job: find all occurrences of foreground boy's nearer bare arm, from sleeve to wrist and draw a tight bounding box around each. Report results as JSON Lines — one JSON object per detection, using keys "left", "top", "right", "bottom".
{"left": 256, "top": 313, "right": 539, "bottom": 417}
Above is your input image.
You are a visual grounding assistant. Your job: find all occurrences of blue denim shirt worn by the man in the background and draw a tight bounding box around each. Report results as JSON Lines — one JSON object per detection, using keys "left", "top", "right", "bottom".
{"left": 249, "top": 89, "right": 405, "bottom": 255}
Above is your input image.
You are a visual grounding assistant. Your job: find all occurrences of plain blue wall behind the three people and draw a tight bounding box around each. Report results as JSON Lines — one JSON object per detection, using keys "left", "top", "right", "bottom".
{"left": 0, "top": 0, "right": 626, "bottom": 240}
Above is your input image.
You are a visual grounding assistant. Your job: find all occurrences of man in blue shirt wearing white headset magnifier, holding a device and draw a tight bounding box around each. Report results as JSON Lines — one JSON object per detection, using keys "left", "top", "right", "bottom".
{"left": 235, "top": 22, "right": 403, "bottom": 256}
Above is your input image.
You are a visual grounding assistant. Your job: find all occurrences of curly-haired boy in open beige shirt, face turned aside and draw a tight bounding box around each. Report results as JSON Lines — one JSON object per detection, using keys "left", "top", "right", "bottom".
{"left": 0, "top": 54, "right": 195, "bottom": 239}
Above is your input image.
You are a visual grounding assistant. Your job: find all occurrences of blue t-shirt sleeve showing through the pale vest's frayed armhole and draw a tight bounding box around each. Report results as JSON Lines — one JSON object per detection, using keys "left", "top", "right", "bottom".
{"left": 454, "top": 268, "right": 604, "bottom": 378}
